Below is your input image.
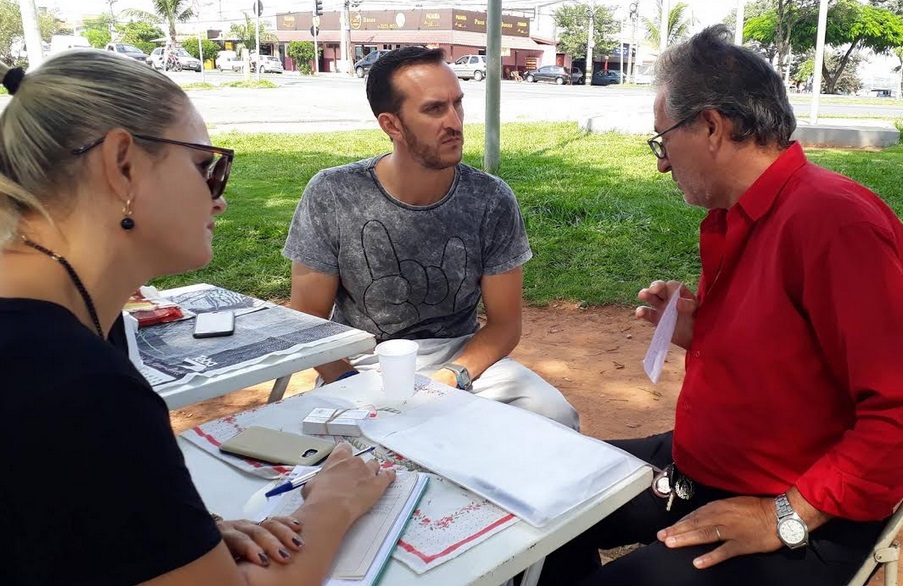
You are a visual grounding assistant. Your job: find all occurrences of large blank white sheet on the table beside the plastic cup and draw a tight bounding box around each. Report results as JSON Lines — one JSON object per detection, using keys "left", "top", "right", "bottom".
{"left": 361, "top": 391, "right": 642, "bottom": 527}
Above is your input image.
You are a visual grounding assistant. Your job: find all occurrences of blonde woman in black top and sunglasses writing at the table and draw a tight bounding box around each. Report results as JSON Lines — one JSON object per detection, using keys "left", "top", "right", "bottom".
{"left": 0, "top": 51, "right": 394, "bottom": 586}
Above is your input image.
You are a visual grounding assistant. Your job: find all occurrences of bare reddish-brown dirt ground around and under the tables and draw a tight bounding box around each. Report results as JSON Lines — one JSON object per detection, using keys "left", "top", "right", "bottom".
{"left": 171, "top": 303, "right": 888, "bottom": 586}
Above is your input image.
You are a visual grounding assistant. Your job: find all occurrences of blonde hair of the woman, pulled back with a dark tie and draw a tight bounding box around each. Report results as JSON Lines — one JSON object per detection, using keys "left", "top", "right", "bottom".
{"left": 0, "top": 49, "right": 188, "bottom": 246}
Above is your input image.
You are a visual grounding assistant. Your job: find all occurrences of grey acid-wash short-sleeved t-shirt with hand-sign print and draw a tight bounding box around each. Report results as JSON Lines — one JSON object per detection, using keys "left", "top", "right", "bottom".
{"left": 282, "top": 157, "right": 532, "bottom": 340}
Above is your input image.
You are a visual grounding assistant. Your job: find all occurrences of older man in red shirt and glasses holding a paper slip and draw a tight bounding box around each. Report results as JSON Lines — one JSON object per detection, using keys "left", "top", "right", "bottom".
{"left": 542, "top": 26, "right": 903, "bottom": 586}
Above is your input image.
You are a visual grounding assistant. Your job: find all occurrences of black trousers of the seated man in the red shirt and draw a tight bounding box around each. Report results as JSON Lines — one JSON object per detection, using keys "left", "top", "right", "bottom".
{"left": 539, "top": 432, "right": 885, "bottom": 586}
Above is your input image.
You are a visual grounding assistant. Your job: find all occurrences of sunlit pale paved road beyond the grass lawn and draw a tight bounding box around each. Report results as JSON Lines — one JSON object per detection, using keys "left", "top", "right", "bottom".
{"left": 0, "top": 72, "right": 903, "bottom": 133}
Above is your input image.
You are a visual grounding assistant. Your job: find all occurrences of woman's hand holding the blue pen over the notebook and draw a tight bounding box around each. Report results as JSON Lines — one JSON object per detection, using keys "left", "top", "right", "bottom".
{"left": 302, "top": 444, "right": 395, "bottom": 527}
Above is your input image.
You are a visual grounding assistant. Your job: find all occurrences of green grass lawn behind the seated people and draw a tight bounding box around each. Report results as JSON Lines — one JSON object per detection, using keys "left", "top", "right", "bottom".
{"left": 155, "top": 123, "right": 903, "bottom": 304}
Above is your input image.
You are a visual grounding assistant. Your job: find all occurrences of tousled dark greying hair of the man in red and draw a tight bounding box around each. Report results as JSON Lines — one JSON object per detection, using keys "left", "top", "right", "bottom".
{"left": 655, "top": 24, "right": 796, "bottom": 148}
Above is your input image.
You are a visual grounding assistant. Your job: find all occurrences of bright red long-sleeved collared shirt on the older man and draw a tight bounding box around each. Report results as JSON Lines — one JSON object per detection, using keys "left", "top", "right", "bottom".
{"left": 673, "top": 144, "right": 903, "bottom": 520}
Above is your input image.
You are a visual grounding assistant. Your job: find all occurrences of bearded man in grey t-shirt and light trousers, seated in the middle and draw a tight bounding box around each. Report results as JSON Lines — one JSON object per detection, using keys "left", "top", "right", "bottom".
{"left": 283, "top": 47, "right": 579, "bottom": 429}
